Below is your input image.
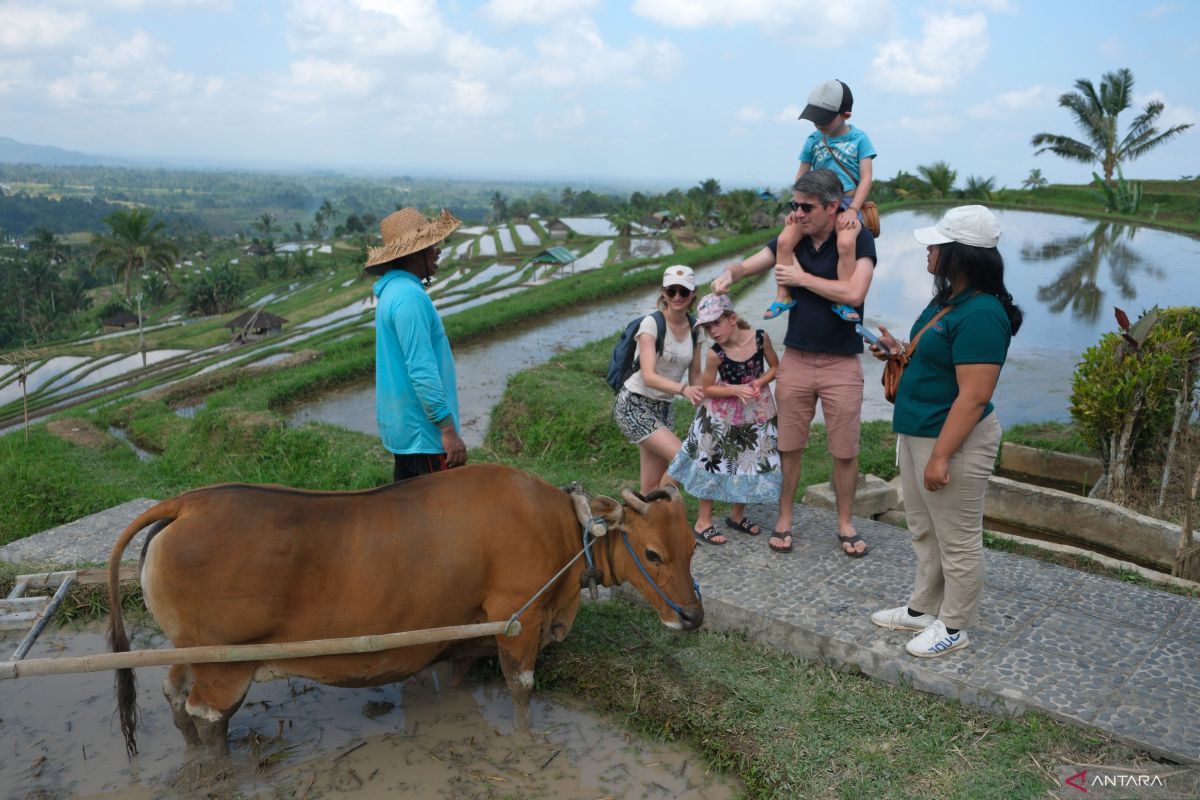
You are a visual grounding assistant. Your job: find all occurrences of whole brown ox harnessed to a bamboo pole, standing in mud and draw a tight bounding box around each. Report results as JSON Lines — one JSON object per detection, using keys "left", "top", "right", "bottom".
{"left": 109, "top": 464, "right": 704, "bottom": 754}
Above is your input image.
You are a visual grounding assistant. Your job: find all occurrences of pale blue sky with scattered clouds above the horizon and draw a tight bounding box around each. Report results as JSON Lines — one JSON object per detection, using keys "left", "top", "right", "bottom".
{"left": 0, "top": 0, "right": 1200, "bottom": 188}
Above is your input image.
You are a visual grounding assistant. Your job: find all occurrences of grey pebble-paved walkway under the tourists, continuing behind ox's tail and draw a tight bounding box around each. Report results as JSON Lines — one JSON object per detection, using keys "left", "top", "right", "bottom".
{"left": 0, "top": 500, "right": 1200, "bottom": 764}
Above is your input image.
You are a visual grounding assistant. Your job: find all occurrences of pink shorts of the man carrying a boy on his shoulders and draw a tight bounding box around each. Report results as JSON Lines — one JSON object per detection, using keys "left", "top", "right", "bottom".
{"left": 775, "top": 348, "right": 863, "bottom": 458}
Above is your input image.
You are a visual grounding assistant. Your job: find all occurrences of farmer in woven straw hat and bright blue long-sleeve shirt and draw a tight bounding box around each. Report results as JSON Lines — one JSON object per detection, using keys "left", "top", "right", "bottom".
{"left": 364, "top": 209, "right": 467, "bottom": 481}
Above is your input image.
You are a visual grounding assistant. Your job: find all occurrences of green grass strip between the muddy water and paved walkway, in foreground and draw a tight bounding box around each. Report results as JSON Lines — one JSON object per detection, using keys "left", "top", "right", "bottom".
{"left": 536, "top": 601, "right": 1144, "bottom": 800}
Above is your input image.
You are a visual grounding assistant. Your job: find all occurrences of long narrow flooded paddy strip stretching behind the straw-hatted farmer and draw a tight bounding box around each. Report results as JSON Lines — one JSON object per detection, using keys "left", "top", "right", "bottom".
{"left": 289, "top": 260, "right": 739, "bottom": 447}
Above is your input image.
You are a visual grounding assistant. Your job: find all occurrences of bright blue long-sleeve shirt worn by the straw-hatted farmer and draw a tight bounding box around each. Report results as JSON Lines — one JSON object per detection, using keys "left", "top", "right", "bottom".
{"left": 373, "top": 270, "right": 460, "bottom": 455}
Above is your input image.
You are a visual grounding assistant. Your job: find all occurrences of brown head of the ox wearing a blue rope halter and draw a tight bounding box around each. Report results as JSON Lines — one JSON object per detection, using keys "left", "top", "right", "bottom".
{"left": 592, "top": 486, "right": 704, "bottom": 631}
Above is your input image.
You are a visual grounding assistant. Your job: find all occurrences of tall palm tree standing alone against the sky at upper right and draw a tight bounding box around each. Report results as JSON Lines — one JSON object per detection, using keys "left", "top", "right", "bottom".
{"left": 1030, "top": 68, "right": 1192, "bottom": 184}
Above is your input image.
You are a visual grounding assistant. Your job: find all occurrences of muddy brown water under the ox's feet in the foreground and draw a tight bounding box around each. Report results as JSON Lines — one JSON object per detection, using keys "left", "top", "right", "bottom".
{"left": 0, "top": 625, "right": 738, "bottom": 800}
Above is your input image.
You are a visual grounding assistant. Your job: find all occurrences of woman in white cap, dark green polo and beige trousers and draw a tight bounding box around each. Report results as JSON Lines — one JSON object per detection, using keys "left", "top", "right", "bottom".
{"left": 871, "top": 205, "right": 1022, "bottom": 657}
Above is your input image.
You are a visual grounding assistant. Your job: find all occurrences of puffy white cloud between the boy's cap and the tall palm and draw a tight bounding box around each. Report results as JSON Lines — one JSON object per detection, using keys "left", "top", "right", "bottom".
{"left": 872, "top": 13, "right": 989, "bottom": 95}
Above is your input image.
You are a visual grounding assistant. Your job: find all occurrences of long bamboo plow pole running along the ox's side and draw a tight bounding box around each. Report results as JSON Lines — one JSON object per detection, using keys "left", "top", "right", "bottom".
{"left": 0, "top": 620, "right": 521, "bottom": 680}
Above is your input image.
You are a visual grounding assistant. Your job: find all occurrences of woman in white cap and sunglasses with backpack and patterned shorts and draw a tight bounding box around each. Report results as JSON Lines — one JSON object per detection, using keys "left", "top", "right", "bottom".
{"left": 612, "top": 265, "right": 704, "bottom": 494}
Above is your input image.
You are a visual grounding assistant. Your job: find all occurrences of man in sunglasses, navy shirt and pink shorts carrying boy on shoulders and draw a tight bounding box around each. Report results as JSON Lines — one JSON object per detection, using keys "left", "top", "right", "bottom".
{"left": 713, "top": 169, "right": 876, "bottom": 558}
